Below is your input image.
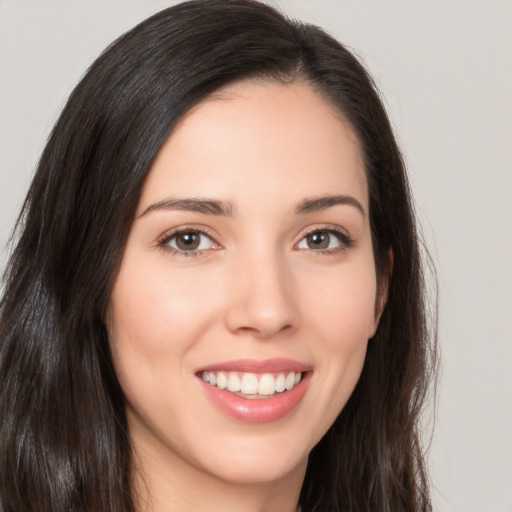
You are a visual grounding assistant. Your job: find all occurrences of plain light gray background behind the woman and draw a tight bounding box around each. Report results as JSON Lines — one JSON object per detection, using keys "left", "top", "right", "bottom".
{"left": 0, "top": 0, "right": 512, "bottom": 512}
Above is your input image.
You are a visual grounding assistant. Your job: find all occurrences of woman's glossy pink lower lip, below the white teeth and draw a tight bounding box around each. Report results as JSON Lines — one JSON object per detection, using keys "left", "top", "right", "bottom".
{"left": 198, "top": 372, "right": 312, "bottom": 423}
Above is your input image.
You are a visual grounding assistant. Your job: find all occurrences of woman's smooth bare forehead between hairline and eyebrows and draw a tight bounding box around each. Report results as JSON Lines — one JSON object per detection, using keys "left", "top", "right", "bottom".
{"left": 136, "top": 81, "right": 368, "bottom": 213}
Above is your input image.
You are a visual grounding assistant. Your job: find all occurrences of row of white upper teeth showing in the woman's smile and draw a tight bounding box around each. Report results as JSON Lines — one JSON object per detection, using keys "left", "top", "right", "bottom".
{"left": 201, "top": 372, "right": 302, "bottom": 397}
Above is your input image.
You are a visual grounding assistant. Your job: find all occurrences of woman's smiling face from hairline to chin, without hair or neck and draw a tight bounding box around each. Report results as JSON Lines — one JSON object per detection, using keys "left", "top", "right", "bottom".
{"left": 109, "top": 82, "right": 377, "bottom": 483}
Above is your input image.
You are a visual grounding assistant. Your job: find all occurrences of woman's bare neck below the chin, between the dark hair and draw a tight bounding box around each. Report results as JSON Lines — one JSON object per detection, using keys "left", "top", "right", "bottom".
{"left": 133, "top": 428, "right": 307, "bottom": 512}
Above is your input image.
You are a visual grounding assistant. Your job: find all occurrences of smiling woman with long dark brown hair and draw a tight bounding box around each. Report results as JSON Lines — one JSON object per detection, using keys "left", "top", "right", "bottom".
{"left": 0, "top": 0, "right": 433, "bottom": 512}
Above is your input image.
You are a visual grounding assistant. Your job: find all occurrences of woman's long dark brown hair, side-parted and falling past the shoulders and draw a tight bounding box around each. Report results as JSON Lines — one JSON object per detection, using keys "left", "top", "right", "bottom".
{"left": 0, "top": 0, "right": 436, "bottom": 512}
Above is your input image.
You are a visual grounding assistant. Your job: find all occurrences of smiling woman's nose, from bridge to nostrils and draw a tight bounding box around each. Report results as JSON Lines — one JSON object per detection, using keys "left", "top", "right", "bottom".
{"left": 226, "top": 250, "right": 299, "bottom": 339}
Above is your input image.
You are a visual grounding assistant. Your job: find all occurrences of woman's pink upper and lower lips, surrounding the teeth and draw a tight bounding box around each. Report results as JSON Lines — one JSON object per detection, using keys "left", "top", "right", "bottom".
{"left": 197, "top": 359, "right": 313, "bottom": 423}
